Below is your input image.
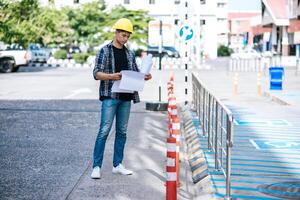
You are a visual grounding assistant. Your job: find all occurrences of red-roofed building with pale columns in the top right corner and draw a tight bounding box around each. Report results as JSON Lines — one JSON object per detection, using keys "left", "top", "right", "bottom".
{"left": 262, "top": 0, "right": 300, "bottom": 57}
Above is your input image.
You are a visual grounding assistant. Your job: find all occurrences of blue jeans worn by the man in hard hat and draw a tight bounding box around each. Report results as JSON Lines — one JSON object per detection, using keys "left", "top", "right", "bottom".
{"left": 93, "top": 99, "right": 131, "bottom": 168}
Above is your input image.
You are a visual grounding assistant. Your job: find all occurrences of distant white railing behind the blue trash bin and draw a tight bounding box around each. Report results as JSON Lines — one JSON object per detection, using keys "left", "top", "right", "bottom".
{"left": 227, "top": 56, "right": 300, "bottom": 75}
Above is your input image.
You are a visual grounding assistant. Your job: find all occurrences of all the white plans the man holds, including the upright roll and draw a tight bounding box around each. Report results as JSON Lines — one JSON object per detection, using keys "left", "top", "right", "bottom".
{"left": 112, "top": 55, "right": 153, "bottom": 93}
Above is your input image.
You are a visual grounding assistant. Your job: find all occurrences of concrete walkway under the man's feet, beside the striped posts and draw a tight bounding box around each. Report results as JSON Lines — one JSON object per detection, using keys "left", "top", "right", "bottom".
{"left": 67, "top": 103, "right": 167, "bottom": 200}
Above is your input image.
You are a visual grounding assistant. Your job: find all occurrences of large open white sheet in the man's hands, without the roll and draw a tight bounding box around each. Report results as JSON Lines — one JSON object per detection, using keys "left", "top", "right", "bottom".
{"left": 119, "top": 70, "right": 145, "bottom": 91}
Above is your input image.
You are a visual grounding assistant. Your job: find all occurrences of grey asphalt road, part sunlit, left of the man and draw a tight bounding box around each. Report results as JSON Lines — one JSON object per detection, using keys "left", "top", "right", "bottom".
{"left": 0, "top": 67, "right": 100, "bottom": 199}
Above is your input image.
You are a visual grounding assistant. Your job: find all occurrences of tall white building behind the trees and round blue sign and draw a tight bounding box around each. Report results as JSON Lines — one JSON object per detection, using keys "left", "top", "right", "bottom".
{"left": 40, "top": 0, "right": 228, "bottom": 58}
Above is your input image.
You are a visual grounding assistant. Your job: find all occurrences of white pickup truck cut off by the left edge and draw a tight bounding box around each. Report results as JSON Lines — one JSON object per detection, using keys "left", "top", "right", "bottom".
{"left": 0, "top": 46, "right": 30, "bottom": 73}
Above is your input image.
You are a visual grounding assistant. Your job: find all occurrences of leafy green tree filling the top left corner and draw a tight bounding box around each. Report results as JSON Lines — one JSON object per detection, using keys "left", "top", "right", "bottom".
{"left": 0, "top": 0, "right": 72, "bottom": 47}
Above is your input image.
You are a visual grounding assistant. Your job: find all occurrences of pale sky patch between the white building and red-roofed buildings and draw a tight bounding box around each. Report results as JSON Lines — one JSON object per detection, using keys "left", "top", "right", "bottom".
{"left": 228, "top": 0, "right": 261, "bottom": 11}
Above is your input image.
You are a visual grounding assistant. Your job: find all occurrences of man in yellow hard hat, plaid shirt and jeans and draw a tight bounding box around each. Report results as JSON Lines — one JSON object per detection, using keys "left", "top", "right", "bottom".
{"left": 91, "top": 18, "right": 152, "bottom": 178}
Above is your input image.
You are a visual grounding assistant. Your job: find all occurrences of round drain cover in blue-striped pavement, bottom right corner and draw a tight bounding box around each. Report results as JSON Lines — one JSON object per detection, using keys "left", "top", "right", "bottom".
{"left": 258, "top": 181, "right": 300, "bottom": 200}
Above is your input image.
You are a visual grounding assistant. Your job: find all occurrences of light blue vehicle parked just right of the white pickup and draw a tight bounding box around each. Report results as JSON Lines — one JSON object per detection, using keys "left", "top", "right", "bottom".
{"left": 28, "top": 44, "right": 50, "bottom": 63}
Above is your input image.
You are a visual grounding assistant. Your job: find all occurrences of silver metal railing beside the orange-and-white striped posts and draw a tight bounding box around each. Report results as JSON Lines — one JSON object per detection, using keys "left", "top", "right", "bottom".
{"left": 192, "top": 74, "right": 234, "bottom": 199}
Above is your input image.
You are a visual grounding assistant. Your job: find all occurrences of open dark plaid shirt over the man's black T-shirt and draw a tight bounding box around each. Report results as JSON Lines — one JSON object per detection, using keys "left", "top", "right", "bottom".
{"left": 93, "top": 42, "right": 140, "bottom": 103}
